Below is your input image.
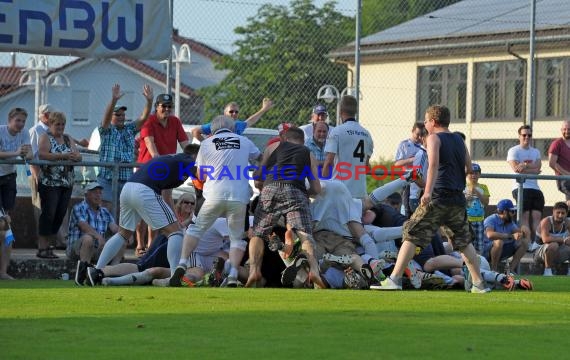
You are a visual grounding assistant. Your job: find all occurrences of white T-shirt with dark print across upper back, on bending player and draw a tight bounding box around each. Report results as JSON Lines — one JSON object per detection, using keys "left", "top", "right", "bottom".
{"left": 196, "top": 131, "right": 260, "bottom": 204}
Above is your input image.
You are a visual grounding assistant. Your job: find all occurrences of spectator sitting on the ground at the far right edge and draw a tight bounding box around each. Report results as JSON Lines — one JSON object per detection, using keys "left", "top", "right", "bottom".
{"left": 534, "top": 202, "right": 570, "bottom": 276}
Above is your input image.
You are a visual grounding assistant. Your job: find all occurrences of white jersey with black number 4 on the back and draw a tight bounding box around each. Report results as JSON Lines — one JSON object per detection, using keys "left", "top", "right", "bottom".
{"left": 325, "top": 120, "right": 374, "bottom": 199}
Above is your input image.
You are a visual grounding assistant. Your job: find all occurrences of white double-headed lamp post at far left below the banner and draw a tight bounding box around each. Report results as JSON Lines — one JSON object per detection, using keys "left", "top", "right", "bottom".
{"left": 19, "top": 55, "right": 71, "bottom": 124}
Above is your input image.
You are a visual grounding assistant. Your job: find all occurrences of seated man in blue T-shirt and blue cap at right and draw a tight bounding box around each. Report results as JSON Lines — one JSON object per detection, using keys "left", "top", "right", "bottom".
{"left": 483, "top": 199, "right": 530, "bottom": 271}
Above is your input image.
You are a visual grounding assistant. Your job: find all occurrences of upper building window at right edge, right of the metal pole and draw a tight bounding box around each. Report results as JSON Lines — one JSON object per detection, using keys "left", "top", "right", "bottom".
{"left": 536, "top": 58, "right": 570, "bottom": 119}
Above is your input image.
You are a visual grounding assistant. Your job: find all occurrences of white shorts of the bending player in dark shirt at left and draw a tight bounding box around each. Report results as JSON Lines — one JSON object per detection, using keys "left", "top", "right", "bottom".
{"left": 119, "top": 182, "right": 178, "bottom": 231}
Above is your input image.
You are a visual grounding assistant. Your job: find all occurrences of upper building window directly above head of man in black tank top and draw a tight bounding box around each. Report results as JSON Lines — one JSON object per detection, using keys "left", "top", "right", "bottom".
{"left": 418, "top": 64, "right": 467, "bottom": 122}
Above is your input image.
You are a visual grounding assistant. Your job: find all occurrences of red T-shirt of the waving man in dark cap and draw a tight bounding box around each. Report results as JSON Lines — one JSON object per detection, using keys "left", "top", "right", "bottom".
{"left": 137, "top": 114, "right": 188, "bottom": 163}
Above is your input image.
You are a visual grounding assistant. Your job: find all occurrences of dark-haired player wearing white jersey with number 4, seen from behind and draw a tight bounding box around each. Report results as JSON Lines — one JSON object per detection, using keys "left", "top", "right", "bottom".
{"left": 323, "top": 95, "right": 374, "bottom": 199}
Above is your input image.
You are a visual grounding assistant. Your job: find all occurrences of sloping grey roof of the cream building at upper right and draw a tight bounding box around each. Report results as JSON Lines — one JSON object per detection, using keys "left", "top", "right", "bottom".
{"left": 330, "top": 0, "right": 570, "bottom": 62}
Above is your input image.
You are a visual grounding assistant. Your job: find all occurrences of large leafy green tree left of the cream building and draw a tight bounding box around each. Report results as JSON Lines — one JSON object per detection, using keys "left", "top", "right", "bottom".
{"left": 200, "top": 0, "right": 354, "bottom": 128}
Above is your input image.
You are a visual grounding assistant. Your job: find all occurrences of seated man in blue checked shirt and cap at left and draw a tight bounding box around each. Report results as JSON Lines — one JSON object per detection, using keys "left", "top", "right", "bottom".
{"left": 70, "top": 182, "right": 118, "bottom": 286}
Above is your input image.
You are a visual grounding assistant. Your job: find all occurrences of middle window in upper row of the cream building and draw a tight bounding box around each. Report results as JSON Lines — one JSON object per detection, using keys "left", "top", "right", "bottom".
{"left": 475, "top": 60, "right": 525, "bottom": 121}
